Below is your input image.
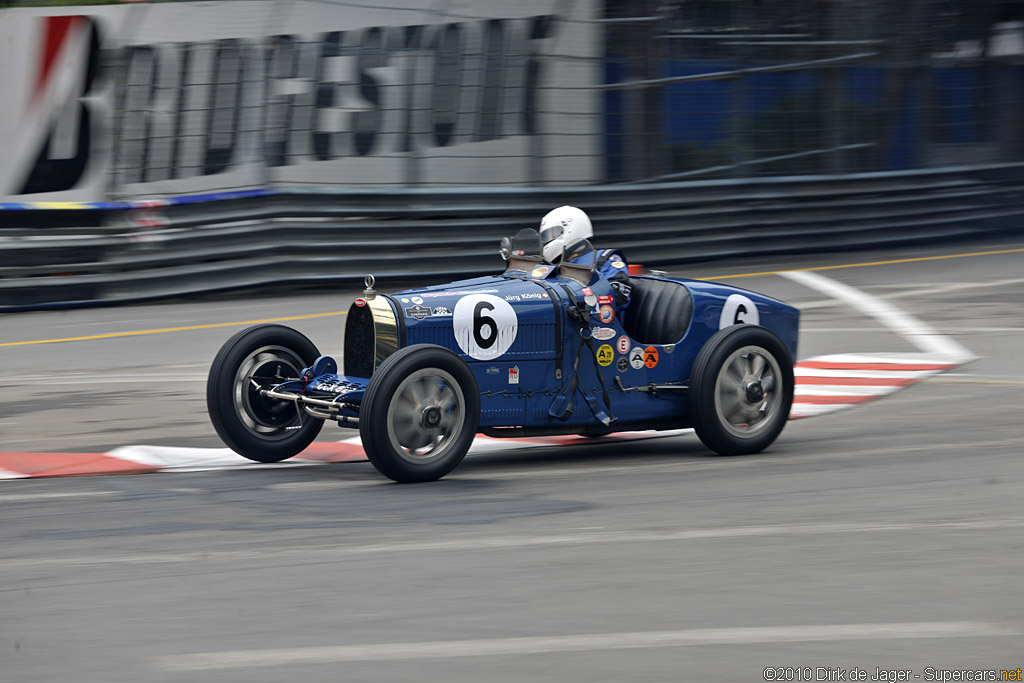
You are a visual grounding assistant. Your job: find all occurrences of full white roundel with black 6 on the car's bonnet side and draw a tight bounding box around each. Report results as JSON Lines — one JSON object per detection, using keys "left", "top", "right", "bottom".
{"left": 452, "top": 294, "right": 519, "bottom": 360}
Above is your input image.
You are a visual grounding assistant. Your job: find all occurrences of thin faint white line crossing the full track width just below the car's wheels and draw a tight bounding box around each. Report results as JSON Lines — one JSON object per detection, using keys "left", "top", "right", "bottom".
{"left": 8, "top": 518, "right": 1024, "bottom": 570}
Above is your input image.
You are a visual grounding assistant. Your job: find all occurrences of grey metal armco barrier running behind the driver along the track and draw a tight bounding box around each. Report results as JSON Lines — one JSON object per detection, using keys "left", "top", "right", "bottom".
{"left": 0, "top": 164, "right": 1024, "bottom": 311}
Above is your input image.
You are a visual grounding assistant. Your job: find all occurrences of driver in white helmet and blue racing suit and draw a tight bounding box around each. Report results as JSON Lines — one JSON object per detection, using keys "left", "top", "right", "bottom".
{"left": 538, "top": 206, "right": 633, "bottom": 314}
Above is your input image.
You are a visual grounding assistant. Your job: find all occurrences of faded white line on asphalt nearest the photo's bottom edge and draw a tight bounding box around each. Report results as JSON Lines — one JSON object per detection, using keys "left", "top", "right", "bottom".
{"left": 156, "top": 622, "right": 1022, "bottom": 672}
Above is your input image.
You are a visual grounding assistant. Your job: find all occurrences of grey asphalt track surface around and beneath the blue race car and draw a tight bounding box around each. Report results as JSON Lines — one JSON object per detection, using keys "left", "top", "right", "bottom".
{"left": 0, "top": 233, "right": 1024, "bottom": 683}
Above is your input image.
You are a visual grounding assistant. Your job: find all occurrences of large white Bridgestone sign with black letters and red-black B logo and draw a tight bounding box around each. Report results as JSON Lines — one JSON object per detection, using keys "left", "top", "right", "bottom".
{"left": 0, "top": 0, "right": 602, "bottom": 201}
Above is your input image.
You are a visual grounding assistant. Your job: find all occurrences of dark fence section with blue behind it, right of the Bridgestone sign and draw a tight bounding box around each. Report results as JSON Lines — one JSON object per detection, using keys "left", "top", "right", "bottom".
{"left": 605, "top": 0, "right": 1024, "bottom": 181}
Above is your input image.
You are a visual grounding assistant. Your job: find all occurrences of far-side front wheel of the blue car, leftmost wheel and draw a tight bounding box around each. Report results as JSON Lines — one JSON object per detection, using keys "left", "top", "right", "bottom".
{"left": 206, "top": 325, "right": 324, "bottom": 463}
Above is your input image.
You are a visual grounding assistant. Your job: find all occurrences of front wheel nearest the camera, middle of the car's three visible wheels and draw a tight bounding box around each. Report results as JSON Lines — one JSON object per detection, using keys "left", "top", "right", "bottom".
{"left": 359, "top": 344, "right": 480, "bottom": 483}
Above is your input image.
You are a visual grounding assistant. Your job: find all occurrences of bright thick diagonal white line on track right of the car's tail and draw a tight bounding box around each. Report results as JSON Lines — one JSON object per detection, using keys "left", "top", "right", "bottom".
{"left": 779, "top": 270, "right": 977, "bottom": 362}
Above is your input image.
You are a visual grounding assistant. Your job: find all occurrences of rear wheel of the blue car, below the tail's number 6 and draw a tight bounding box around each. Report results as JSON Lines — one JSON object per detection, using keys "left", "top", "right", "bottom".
{"left": 689, "top": 325, "right": 794, "bottom": 456}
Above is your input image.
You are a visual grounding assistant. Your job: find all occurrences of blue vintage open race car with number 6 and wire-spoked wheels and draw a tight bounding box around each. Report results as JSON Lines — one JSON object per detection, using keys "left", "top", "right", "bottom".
{"left": 207, "top": 230, "right": 800, "bottom": 481}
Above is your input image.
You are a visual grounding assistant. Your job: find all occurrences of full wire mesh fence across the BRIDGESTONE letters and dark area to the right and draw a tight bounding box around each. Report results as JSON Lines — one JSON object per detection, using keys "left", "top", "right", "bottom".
{"left": 97, "top": 0, "right": 1024, "bottom": 192}
